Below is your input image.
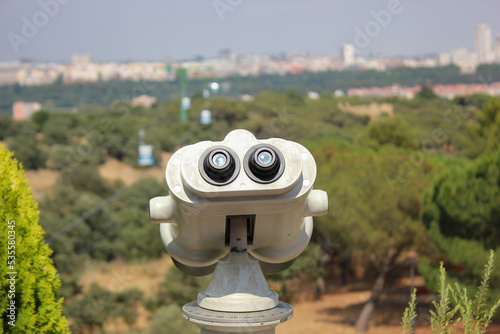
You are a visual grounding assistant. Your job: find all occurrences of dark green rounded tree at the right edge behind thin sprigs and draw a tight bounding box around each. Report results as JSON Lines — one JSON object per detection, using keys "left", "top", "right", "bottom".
{"left": 419, "top": 151, "right": 500, "bottom": 310}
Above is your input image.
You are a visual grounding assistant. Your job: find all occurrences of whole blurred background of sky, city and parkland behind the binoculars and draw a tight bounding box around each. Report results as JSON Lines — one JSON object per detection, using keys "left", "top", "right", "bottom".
{"left": 0, "top": 0, "right": 500, "bottom": 334}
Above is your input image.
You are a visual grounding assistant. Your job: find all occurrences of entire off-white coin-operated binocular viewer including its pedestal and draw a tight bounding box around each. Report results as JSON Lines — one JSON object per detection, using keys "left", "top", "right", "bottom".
{"left": 150, "top": 130, "right": 328, "bottom": 333}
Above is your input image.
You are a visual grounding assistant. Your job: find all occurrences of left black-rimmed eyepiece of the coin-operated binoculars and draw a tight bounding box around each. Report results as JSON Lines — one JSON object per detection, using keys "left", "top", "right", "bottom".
{"left": 198, "top": 147, "right": 240, "bottom": 186}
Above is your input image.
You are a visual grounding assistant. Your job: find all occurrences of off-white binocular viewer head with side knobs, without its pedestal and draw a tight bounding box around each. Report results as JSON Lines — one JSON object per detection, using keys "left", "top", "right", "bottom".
{"left": 150, "top": 130, "right": 328, "bottom": 275}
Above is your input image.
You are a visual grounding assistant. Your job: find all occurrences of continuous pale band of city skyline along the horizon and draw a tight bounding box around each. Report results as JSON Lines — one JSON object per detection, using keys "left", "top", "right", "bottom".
{"left": 0, "top": 23, "right": 500, "bottom": 86}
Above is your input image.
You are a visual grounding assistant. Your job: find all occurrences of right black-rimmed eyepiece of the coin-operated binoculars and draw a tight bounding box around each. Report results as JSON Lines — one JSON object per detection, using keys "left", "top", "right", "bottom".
{"left": 245, "top": 145, "right": 285, "bottom": 183}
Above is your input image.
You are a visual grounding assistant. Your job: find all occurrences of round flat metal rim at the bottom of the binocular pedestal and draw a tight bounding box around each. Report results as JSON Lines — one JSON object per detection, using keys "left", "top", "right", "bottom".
{"left": 182, "top": 301, "right": 293, "bottom": 334}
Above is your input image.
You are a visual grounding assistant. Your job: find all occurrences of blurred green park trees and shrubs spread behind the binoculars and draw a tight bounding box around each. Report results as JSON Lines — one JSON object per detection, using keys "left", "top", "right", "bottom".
{"left": 0, "top": 67, "right": 500, "bottom": 333}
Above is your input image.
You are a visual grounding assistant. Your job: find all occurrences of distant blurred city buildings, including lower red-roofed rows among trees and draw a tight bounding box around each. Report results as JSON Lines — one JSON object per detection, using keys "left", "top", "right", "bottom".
{"left": 5, "top": 23, "right": 500, "bottom": 120}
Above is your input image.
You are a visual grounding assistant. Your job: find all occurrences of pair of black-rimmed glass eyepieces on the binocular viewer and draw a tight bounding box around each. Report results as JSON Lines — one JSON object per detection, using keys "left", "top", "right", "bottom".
{"left": 198, "top": 144, "right": 285, "bottom": 186}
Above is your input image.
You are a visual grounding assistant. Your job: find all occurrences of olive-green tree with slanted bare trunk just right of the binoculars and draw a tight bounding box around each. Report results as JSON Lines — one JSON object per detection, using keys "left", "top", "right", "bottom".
{"left": 309, "top": 139, "right": 446, "bottom": 333}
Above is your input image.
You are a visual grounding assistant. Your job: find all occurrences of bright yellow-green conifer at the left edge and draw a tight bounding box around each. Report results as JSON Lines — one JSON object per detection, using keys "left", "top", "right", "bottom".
{"left": 0, "top": 147, "right": 69, "bottom": 333}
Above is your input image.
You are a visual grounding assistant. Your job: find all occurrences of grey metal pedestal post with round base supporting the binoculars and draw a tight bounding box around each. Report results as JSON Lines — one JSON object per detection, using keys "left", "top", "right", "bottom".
{"left": 182, "top": 218, "right": 293, "bottom": 334}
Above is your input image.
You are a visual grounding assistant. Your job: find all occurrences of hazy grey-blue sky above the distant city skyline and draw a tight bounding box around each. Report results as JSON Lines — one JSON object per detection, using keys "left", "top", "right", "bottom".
{"left": 0, "top": 0, "right": 500, "bottom": 61}
